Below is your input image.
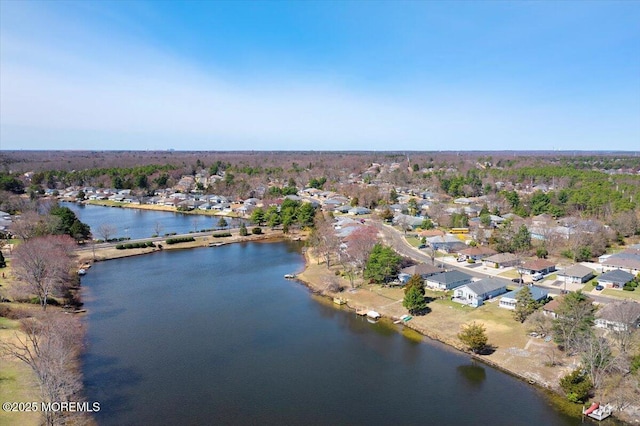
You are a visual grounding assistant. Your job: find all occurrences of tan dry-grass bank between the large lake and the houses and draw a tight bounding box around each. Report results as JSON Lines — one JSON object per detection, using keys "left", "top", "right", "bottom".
{"left": 298, "top": 251, "right": 592, "bottom": 415}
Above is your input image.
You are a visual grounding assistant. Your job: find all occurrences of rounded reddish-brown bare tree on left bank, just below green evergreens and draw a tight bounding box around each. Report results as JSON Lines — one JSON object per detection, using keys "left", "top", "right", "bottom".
{"left": 13, "top": 235, "right": 76, "bottom": 310}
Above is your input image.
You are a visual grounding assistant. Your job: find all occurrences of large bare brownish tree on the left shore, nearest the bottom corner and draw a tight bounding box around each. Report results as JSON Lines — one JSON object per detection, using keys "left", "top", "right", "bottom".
{"left": 0, "top": 312, "right": 82, "bottom": 425}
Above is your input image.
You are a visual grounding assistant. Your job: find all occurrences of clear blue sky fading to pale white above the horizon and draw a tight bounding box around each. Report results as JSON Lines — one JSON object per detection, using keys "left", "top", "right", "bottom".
{"left": 0, "top": 0, "right": 640, "bottom": 151}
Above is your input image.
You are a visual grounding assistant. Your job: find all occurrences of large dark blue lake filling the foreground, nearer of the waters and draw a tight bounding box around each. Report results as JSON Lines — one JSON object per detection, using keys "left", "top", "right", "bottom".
{"left": 83, "top": 243, "right": 580, "bottom": 426}
